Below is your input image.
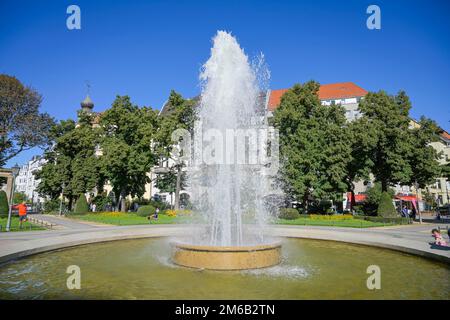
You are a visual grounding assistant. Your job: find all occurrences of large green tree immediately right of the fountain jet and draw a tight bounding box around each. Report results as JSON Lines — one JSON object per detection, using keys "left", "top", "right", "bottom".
{"left": 274, "top": 81, "right": 351, "bottom": 207}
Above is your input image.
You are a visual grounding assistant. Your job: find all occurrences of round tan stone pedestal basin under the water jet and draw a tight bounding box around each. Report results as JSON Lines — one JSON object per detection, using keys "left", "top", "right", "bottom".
{"left": 172, "top": 242, "right": 281, "bottom": 270}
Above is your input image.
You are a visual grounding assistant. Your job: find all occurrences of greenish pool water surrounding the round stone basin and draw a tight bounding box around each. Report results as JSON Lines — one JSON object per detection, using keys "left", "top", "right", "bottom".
{"left": 0, "top": 238, "right": 450, "bottom": 299}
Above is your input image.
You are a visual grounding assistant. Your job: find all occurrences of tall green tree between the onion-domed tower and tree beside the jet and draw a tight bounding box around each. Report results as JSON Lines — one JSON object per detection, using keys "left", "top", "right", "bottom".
{"left": 100, "top": 96, "right": 159, "bottom": 212}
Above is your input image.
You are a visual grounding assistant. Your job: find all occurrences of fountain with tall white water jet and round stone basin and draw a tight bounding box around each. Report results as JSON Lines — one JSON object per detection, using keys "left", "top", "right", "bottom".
{"left": 173, "top": 31, "right": 281, "bottom": 270}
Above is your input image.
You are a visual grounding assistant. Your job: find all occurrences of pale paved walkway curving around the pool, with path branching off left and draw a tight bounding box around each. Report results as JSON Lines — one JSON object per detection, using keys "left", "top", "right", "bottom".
{"left": 0, "top": 221, "right": 450, "bottom": 264}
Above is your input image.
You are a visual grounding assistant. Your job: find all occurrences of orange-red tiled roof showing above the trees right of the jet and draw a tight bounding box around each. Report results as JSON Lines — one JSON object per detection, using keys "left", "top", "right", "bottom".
{"left": 267, "top": 82, "right": 367, "bottom": 111}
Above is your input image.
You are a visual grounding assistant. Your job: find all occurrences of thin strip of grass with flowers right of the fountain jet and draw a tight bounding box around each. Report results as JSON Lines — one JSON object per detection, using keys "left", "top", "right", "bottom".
{"left": 275, "top": 217, "right": 393, "bottom": 228}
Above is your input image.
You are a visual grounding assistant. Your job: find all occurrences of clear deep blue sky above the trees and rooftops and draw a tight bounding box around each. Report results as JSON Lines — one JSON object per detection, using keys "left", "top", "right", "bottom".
{"left": 0, "top": 0, "right": 450, "bottom": 165}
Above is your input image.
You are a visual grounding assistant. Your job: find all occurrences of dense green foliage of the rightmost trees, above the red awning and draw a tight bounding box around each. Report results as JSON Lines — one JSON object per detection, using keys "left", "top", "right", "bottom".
{"left": 359, "top": 91, "right": 439, "bottom": 191}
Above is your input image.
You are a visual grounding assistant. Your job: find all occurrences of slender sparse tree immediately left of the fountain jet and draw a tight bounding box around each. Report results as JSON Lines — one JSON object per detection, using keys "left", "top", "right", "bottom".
{"left": 155, "top": 90, "right": 196, "bottom": 210}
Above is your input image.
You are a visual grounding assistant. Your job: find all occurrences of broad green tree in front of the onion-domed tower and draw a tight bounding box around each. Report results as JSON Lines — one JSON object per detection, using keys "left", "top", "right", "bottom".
{"left": 35, "top": 111, "right": 105, "bottom": 210}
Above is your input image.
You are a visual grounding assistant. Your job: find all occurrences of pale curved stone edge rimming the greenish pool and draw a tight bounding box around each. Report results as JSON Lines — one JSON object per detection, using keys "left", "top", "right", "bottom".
{"left": 0, "top": 225, "right": 450, "bottom": 264}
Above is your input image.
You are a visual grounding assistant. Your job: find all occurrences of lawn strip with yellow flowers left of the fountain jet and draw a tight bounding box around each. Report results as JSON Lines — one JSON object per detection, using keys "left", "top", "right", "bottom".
{"left": 67, "top": 212, "right": 186, "bottom": 226}
